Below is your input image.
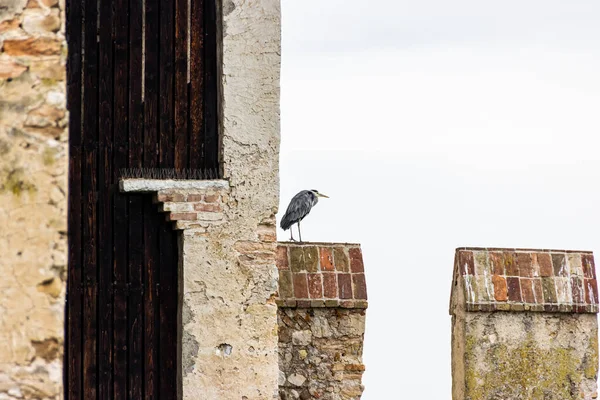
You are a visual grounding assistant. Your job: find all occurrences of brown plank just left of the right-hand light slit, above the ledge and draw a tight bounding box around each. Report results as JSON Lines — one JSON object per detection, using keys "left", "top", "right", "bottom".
{"left": 174, "top": 0, "right": 189, "bottom": 169}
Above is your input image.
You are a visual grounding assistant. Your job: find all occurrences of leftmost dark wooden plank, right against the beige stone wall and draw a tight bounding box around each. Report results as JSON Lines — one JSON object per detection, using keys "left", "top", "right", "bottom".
{"left": 64, "top": 0, "right": 83, "bottom": 399}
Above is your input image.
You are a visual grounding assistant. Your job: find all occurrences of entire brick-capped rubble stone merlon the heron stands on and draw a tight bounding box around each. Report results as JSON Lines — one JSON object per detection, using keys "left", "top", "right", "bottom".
{"left": 277, "top": 243, "right": 368, "bottom": 400}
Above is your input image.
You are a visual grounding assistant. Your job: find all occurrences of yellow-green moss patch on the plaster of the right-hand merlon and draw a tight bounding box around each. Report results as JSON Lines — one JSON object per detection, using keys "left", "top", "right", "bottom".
{"left": 465, "top": 335, "right": 597, "bottom": 400}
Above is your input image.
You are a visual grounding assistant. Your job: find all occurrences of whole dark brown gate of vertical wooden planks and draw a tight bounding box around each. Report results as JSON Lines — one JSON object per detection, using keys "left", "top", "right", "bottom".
{"left": 64, "top": 0, "right": 219, "bottom": 400}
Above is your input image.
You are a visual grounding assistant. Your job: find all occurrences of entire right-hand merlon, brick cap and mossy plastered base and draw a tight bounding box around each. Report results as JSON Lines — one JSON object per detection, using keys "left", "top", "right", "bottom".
{"left": 450, "top": 248, "right": 598, "bottom": 400}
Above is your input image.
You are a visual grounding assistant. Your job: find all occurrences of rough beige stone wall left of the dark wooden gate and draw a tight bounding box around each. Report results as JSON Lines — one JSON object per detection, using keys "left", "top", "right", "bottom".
{"left": 0, "top": 0, "right": 67, "bottom": 399}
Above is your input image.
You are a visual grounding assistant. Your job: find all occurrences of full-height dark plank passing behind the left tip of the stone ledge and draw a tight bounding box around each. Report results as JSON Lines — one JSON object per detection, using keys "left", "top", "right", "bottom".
{"left": 113, "top": 0, "right": 129, "bottom": 399}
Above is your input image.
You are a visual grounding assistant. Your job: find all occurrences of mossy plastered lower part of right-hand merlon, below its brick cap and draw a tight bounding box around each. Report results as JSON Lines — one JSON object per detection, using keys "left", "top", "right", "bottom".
{"left": 464, "top": 312, "right": 598, "bottom": 400}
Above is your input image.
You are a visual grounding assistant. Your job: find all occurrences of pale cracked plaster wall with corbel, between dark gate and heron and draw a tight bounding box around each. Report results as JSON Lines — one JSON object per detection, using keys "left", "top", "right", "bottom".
{"left": 122, "top": 0, "right": 280, "bottom": 400}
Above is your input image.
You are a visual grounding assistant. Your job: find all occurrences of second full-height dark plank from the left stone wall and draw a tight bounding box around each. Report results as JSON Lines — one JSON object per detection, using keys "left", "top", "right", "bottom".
{"left": 82, "top": 0, "right": 98, "bottom": 400}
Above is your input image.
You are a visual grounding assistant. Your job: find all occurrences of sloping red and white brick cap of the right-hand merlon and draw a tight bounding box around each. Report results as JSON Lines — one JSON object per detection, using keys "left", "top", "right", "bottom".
{"left": 456, "top": 248, "right": 599, "bottom": 313}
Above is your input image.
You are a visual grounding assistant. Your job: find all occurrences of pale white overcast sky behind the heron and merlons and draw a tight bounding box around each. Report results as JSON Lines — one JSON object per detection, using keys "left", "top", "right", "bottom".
{"left": 279, "top": 0, "right": 600, "bottom": 400}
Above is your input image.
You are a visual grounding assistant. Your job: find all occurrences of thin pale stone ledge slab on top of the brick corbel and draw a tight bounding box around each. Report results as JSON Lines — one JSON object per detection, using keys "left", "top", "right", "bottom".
{"left": 119, "top": 178, "right": 229, "bottom": 193}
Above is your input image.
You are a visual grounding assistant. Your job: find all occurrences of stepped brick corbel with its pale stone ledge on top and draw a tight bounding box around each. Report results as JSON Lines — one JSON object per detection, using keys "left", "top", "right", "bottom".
{"left": 119, "top": 178, "right": 229, "bottom": 234}
